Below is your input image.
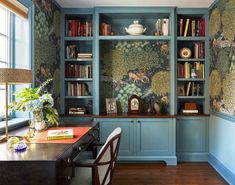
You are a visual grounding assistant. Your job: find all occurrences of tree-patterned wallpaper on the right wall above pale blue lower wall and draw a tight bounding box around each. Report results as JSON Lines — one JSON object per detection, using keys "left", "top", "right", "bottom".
{"left": 209, "top": 0, "right": 235, "bottom": 116}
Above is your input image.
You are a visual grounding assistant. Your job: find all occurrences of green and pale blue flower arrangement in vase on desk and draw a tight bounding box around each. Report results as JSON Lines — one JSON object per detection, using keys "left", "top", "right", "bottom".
{"left": 9, "top": 79, "right": 59, "bottom": 131}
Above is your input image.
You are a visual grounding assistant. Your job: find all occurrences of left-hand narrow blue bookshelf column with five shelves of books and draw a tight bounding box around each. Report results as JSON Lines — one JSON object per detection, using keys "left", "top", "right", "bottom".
{"left": 61, "top": 10, "right": 94, "bottom": 116}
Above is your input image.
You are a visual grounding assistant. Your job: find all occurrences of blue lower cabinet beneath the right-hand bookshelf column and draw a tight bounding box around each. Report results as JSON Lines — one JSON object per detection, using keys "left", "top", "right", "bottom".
{"left": 177, "top": 117, "right": 208, "bottom": 161}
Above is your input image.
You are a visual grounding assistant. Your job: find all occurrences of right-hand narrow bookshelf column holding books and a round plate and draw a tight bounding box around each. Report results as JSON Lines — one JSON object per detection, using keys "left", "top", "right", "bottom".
{"left": 176, "top": 9, "right": 208, "bottom": 114}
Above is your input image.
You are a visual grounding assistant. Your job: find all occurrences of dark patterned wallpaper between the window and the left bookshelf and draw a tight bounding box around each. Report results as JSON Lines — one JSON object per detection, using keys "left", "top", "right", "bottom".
{"left": 33, "top": 0, "right": 60, "bottom": 109}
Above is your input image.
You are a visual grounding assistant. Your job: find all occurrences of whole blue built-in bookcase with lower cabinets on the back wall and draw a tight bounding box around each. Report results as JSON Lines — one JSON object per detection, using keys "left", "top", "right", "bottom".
{"left": 61, "top": 7, "right": 209, "bottom": 165}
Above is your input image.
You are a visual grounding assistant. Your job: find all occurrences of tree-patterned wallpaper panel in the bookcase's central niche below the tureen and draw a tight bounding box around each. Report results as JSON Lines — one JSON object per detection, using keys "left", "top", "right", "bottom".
{"left": 100, "top": 40, "right": 170, "bottom": 114}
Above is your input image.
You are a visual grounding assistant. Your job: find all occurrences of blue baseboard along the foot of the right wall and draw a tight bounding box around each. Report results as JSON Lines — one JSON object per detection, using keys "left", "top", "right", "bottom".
{"left": 208, "top": 154, "right": 235, "bottom": 185}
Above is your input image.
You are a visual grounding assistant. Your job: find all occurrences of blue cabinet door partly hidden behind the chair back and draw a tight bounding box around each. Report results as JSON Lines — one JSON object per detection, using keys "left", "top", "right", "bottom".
{"left": 96, "top": 118, "right": 134, "bottom": 156}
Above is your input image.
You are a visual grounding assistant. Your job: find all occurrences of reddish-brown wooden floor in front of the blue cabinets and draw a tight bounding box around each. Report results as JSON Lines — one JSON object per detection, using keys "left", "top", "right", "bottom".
{"left": 112, "top": 163, "right": 228, "bottom": 185}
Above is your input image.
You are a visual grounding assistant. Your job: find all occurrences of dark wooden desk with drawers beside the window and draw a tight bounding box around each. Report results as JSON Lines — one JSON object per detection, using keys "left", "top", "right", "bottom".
{"left": 0, "top": 122, "right": 99, "bottom": 185}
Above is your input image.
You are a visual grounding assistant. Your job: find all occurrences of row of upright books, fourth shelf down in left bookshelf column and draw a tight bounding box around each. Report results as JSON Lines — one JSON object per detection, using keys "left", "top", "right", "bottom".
{"left": 65, "top": 82, "right": 91, "bottom": 96}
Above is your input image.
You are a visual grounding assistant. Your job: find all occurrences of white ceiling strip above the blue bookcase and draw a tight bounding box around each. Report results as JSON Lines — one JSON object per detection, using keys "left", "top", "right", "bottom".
{"left": 56, "top": 0, "right": 214, "bottom": 8}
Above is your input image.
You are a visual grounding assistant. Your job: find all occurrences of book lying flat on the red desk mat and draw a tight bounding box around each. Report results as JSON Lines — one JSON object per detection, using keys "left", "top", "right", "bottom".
{"left": 47, "top": 129, "right": 74, "bottom": 140}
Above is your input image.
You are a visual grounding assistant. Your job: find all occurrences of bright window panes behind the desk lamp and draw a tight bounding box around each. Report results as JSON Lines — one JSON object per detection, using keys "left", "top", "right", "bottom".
{"left": 0, "top": 6, "right": 31, "bottom": 121}
